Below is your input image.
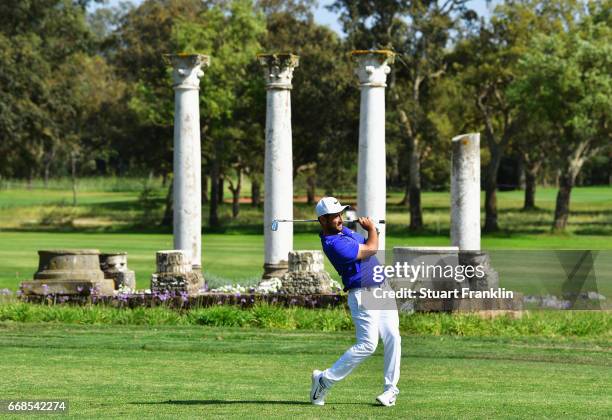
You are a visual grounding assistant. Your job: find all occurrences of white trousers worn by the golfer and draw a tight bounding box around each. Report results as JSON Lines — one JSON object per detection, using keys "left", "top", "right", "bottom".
{"left": 323, "top": 288, "right": 402, "bottom": 393}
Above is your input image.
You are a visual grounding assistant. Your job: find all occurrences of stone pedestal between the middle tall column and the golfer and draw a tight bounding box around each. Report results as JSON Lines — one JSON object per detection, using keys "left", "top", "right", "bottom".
{"left": 280, "top": 251, "right": 332, "bottom": 295}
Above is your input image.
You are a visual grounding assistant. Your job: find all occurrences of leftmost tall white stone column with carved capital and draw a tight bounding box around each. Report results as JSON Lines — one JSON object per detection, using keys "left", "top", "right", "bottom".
{"left": 165, "top": 54, "right": 210, "bottom": 270}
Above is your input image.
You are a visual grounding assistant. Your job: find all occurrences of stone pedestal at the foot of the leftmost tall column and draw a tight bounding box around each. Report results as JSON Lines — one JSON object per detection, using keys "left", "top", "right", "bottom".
{"left": 151, "top": 250, "right": 204, "bottom": 295}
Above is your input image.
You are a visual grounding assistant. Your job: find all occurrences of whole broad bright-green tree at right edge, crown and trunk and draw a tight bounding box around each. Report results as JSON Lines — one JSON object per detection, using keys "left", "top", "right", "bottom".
{"left": 512, "top": 2, "right": 612, "bottom": 230}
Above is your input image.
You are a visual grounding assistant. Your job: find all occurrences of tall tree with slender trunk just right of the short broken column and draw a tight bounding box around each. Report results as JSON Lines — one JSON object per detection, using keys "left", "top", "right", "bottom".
{"left": 453, "top": 0, "right": 579, "bottom": 232}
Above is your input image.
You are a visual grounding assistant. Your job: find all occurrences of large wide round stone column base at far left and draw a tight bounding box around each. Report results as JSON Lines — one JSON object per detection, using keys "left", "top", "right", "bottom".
{"left": 20, "top": 249, "right": 115, "bottom": 296}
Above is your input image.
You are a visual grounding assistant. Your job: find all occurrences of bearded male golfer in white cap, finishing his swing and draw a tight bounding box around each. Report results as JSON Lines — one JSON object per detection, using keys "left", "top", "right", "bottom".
{"left": 310, "top": 197, "right": 401, "bottom": 406}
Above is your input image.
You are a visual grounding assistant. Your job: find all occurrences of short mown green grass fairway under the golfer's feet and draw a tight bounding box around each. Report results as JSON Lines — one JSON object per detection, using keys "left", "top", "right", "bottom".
{"left": 0, "top": 322, "right": 612, "bottom": 418}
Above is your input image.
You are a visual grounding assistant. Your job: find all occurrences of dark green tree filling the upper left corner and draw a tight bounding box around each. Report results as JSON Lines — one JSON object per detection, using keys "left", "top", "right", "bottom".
{"left": 0, "top": 0, "right": 91, "bottom": 179}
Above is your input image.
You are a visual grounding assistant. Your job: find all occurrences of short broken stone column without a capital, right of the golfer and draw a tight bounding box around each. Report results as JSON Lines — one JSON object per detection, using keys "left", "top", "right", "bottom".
{"left": 451, "top": 133, "right": 480, "bottom": 251}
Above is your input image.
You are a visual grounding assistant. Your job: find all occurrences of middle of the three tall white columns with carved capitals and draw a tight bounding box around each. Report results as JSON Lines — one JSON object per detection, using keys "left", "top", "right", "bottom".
{"left": 257, "top": 54, "right": 299, "bottom": 279}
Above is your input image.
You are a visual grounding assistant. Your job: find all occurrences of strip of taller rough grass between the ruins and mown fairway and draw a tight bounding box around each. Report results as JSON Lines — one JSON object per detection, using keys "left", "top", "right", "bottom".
{"left": 0, "top": 302, "right": 612, "bottom": 340}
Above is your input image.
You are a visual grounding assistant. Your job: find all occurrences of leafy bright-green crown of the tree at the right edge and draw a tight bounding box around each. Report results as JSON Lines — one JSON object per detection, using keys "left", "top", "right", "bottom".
{"left": 511, "top": 9, "right": 612, "bottom": 153}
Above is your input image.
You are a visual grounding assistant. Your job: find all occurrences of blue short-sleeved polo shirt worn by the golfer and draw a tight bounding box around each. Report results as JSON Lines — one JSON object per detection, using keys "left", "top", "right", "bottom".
{"left": 319, "top": 226, "right": 381, "bottom": 291}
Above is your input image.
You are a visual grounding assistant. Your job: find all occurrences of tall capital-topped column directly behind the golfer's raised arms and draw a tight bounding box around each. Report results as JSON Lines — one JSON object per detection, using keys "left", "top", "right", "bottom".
{"left": 352, "top": 50, "right": 394, "bottom": 249}
